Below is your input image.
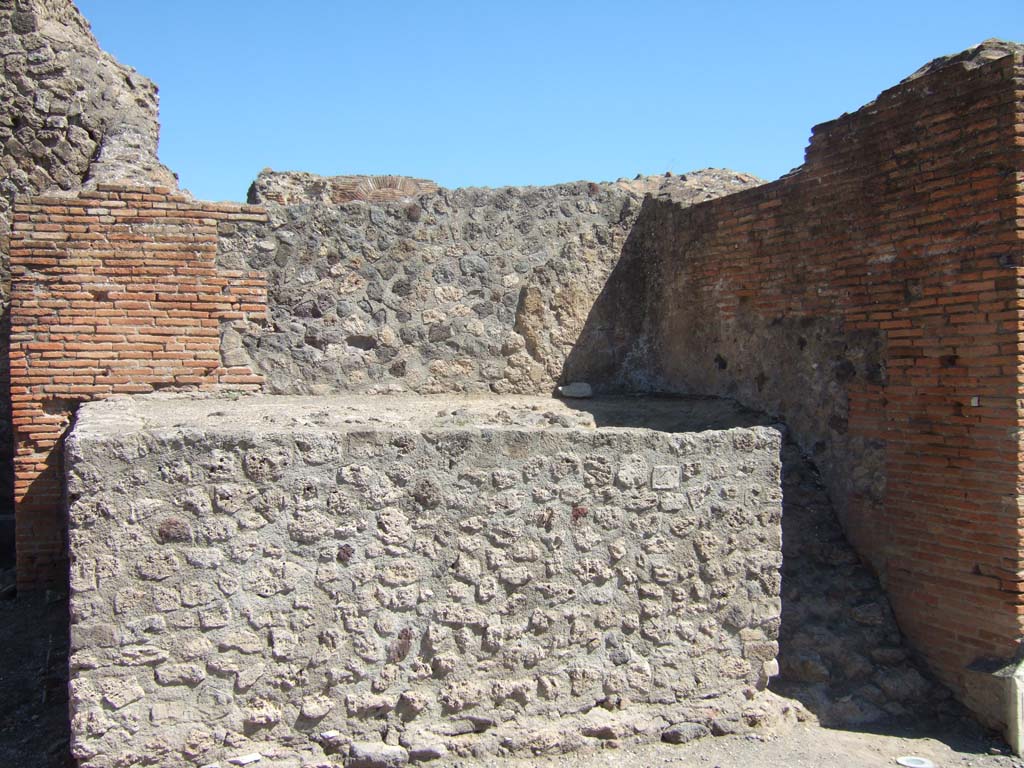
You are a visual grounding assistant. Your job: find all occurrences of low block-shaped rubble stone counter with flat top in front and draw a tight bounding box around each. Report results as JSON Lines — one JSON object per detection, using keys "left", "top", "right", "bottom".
{"left": 66, "top": 395, "right": 781, "bottom": 767}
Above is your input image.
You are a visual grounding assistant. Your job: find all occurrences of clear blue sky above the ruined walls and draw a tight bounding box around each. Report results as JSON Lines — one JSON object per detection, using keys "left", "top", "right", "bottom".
{"left": 77, "top": 0, "right": 1024, "bottom": 200}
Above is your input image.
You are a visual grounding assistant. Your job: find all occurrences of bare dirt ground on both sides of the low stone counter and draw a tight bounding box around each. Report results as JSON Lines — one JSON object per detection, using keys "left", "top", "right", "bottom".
{"left": 0, "top": 571, "right": 1024, "bottom": 768}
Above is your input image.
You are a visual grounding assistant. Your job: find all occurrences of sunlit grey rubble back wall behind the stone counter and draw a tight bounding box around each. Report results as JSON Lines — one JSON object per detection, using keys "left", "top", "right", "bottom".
{"left": 219, "top": 170, "right": 758, "bottom": 393}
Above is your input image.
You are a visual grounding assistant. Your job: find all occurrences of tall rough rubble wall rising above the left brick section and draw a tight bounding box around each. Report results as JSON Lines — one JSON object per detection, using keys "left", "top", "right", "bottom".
{"left": 0, "top": 0, "right": 176, "bottom": 568}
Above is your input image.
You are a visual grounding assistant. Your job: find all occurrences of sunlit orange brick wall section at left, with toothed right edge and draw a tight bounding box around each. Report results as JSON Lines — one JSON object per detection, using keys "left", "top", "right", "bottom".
{"left": 10, "top": 185, "right": 266, "bottom": 587}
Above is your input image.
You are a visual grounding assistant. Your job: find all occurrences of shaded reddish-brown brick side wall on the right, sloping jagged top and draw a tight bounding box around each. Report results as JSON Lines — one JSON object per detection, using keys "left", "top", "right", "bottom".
{"left": 585, "top": 45, "right": 1024, "bottom": 720}
